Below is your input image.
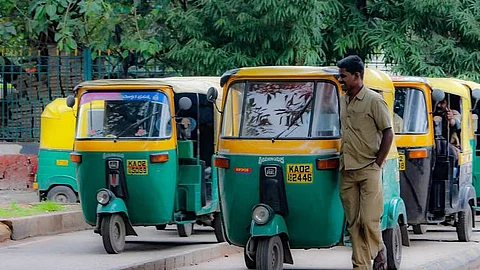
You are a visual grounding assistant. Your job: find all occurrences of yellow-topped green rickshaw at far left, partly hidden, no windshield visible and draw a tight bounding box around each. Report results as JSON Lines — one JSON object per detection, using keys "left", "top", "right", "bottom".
{"left": 33, "top": 98, "right": 78, "bottom": 203}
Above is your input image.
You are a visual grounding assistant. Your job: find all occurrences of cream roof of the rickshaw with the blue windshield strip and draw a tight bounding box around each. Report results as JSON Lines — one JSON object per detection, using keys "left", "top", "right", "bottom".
{"left": 75, "top": 77, "right": 221, "bottom": 94}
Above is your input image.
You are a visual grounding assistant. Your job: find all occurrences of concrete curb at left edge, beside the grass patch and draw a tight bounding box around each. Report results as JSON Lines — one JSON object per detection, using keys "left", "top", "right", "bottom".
{"left": 0, "top": 211, "right": 92, "bottom": 240}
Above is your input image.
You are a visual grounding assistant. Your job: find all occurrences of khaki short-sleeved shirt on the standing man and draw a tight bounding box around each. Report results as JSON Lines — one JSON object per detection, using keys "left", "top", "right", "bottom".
{"left": 340, "top": 86, "right": 392, "bottom": 170}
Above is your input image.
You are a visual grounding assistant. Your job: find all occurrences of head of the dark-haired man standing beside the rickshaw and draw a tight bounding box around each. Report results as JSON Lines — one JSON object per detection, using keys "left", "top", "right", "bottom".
{"left": 337, "top": 55, "right": 365, "bottom": 95}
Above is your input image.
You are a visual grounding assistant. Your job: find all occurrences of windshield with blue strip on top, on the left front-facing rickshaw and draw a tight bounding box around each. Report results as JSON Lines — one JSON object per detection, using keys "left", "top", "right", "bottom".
{"left": 76, "top": 91, "right": 172, "bottom": 139}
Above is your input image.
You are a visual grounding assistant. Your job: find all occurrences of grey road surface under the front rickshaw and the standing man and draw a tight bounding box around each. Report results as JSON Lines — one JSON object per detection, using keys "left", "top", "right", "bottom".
{"left": 181, "top": 222, "right": 480, "bottom": 270}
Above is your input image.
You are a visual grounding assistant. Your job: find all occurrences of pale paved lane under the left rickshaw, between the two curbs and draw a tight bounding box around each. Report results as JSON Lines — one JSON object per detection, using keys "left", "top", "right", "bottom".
{"left": 0, "top": 226, "right": 217, "bottom": 270}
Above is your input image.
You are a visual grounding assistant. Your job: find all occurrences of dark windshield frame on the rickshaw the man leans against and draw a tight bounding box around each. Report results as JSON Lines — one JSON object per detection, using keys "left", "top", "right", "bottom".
{"left": 219, "top": 78, "right": 342, "bottom": 141}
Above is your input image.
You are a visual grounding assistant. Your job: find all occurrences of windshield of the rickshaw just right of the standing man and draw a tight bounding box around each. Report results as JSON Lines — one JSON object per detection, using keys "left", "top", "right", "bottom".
{"left": 393, "top": 87, "right": 428, "bottom": 134}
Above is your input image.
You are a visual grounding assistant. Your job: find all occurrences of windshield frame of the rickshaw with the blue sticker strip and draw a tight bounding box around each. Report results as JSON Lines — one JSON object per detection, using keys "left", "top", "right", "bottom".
{"left": 74, "top": 87, "right": 172, "bottom": 141}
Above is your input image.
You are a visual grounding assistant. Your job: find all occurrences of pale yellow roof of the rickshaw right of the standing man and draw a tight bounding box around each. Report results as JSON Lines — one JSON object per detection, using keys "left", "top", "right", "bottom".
{"left": 392, "top": 76, "right": 470, "bottom": 98}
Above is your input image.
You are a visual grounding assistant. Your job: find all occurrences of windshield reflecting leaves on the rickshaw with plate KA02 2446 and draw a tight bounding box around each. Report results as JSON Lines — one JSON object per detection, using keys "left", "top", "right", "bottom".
{"left": 221, "top": 80, "right": 340, "bottom": 139}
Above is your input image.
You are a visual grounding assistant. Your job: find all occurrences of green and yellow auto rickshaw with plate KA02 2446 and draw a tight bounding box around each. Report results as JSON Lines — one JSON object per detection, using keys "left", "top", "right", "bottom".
{"left": 207, "top": 66, "right": 408, "bottom": 270}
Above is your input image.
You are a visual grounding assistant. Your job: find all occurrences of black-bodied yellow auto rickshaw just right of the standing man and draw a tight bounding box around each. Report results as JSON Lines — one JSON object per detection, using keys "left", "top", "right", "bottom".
{"left": 393, "top": 77, "right": 476, "bottom": 242}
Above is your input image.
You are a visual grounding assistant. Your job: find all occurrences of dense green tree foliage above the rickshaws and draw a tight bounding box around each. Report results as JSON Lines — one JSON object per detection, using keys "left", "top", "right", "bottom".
{"left": 0, "top": 0, "right": 480, "bottom": 81}
